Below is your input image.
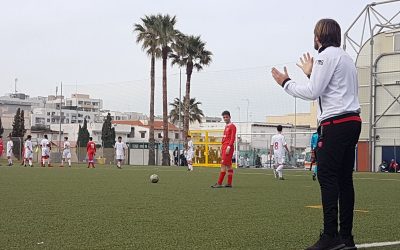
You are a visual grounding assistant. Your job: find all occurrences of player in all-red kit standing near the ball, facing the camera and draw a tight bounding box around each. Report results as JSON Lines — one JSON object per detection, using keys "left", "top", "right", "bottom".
{"left": 211, "top": 111, "right": 236, "bottom": 188}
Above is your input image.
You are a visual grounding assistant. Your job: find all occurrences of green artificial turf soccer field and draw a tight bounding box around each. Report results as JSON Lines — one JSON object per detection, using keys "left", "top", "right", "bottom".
{"left": 0, "top": 164, "right": 400, "bottom": 249}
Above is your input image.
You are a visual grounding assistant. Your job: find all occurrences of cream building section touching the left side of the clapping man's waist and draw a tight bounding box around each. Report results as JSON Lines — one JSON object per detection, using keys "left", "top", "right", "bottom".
{"left": 267, "top": 102, "right": 317, "bottom": 129}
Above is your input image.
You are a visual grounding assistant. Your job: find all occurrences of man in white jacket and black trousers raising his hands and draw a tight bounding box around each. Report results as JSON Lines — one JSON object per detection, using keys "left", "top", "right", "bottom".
{"left": 272, "top": 19, "right": 361, "bottom": 250}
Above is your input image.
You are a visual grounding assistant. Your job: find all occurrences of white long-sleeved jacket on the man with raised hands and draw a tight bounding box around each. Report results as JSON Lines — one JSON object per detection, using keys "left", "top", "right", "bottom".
{"left": 284, "top": 47, "right": 360, "bottom": 122}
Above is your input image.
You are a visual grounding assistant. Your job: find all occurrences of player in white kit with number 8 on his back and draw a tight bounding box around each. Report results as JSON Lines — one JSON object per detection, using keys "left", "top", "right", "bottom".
{"left": 270, "top": 125, "right": 289, "bottom": 180}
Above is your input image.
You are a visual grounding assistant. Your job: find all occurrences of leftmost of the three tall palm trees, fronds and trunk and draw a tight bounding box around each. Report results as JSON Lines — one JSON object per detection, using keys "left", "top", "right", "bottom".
{"left": 134, "top": 15, "right": 161, "bottom": 165}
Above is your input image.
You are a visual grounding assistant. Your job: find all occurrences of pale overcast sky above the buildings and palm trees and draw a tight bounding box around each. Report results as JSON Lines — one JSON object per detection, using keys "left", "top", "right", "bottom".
{"left": 0, "top": 0, "right": 382, "bottom": 121}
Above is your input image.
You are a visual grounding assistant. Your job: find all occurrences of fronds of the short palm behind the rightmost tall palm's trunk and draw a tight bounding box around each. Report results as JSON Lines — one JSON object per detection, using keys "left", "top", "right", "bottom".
{"left": 169, "top": 97, "right": 204, "bottom": 124}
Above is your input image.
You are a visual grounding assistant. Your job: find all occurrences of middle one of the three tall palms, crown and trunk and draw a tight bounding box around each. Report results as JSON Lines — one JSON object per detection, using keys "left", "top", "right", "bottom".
{"left": 154, "top": 14, "right": 181, "bottom": 166}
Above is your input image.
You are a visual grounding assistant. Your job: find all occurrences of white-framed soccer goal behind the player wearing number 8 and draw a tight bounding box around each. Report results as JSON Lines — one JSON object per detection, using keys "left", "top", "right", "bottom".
{"left": 235, "top": 129, "right": 315, "bottom": 168}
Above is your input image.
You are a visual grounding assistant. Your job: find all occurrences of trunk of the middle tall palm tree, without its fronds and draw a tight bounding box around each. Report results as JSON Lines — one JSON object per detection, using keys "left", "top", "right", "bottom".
{"left": 162, "top": 48, "right": 171, "bottom": 166}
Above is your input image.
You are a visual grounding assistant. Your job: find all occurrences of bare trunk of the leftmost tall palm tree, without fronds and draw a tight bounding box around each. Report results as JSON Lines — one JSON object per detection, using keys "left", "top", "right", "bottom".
{"left": 149, "top": 55, "right": 156, "bottom": 166}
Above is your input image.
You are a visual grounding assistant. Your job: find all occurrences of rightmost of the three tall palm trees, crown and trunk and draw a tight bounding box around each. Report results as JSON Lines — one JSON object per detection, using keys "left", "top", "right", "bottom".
{"left": 171, "top": 36, "right": 212, "bottom": 145}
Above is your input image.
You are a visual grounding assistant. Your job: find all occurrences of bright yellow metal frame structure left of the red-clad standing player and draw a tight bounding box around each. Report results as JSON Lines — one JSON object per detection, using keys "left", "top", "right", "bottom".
{"left": 189, "top": 130, "right": 236, "bottom": 167}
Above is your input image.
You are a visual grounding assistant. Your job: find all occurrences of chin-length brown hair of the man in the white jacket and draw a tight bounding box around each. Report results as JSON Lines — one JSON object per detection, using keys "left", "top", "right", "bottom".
{"left": 314, "top": 19, "right": 341, "bottom": 47}
